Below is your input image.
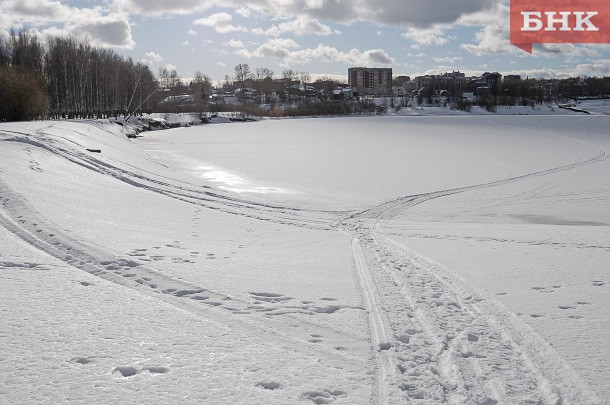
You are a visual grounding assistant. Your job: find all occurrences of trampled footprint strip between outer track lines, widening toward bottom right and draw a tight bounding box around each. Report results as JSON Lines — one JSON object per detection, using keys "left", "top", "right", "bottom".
{"left": 354, "top": 236, "right": 564, "bottom": 404}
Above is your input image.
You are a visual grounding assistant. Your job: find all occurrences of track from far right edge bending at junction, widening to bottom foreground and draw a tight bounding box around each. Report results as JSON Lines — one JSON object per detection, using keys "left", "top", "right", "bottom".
{"left": 333, "top": 135, "right": 608, "bottom": 405}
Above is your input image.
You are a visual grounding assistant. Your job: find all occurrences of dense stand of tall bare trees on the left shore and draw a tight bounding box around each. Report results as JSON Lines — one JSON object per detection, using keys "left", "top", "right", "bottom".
{"left": 0, "top": 31, "right": 157, "bottom": 121}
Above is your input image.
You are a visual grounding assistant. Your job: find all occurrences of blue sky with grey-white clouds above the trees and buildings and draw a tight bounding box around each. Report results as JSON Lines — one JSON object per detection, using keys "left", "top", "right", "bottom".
{"left": 0, "top": 0, "right": 610, "bottom": 80}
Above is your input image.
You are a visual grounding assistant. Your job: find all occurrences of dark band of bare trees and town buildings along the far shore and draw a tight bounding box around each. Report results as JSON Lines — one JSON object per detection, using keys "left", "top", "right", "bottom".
{"left": 0, "top": 31, "right": 610, "bottom": 121}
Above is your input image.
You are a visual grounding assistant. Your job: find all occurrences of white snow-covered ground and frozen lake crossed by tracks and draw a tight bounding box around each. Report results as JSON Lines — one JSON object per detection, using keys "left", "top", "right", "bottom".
{"left": 0, "top": 116, "right": 610, "bottom": 404}
